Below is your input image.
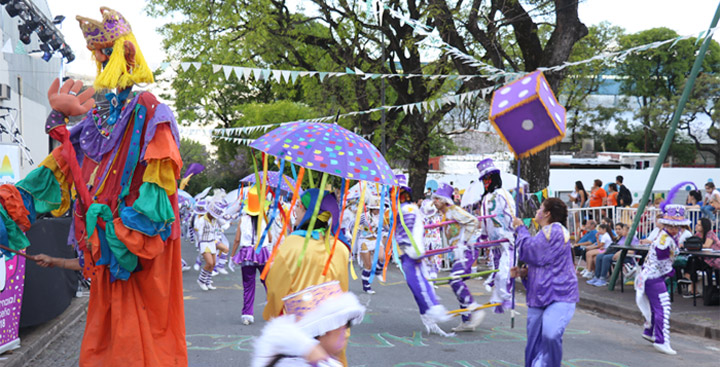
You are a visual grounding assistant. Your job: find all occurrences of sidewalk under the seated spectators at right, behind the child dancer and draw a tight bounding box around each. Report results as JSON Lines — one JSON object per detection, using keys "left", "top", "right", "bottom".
{"left": 578, "top": 277, "right": 720, "bottom": 340}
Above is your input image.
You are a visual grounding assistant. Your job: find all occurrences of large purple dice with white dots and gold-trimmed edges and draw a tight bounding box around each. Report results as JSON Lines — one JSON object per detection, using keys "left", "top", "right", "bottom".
{"left": 490, "top": 71, "right": 565, "bottom": 158}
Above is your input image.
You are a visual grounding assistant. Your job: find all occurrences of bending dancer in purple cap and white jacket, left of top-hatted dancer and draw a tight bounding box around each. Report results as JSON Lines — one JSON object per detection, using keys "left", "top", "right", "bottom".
{"left": 432, "top": 184, "right": 485, "bottom": 331}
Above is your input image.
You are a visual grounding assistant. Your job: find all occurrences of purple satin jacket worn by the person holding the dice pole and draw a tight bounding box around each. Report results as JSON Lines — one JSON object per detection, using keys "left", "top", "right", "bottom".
{"left": 515, "top": 223, "right": 580, "bottom": 307}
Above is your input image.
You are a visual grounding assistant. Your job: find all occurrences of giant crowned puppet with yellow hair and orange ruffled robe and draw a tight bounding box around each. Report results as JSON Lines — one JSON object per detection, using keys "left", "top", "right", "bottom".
{"left": 0, "top": 8, "right": 188, "bottom": 366}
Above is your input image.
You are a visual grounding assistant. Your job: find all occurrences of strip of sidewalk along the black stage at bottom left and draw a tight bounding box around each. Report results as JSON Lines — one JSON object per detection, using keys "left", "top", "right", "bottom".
{"left": 0, "top": 296, "right": 89, "bottom": 367}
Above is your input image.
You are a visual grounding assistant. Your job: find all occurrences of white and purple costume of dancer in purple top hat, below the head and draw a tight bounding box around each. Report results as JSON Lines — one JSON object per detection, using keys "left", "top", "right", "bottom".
{"left": 480, "top": 188, "right": 517, "bottom": 313}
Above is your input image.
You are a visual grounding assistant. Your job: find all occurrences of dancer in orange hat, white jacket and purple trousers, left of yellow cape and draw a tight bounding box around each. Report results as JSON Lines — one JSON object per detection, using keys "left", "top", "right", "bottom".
{"left": 233, "top": 185, "right": 274, "bottom": 325}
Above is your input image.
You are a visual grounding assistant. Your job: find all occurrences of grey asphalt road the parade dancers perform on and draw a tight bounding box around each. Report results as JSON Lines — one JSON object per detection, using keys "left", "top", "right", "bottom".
{"left": 28, "top": 233, "right": 720, "bottom": 367}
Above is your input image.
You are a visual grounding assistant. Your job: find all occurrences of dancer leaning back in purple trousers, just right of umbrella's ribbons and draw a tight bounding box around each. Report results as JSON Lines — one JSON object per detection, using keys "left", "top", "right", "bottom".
{"left": 395, "top": 175, "right": 451, "bottom": 336}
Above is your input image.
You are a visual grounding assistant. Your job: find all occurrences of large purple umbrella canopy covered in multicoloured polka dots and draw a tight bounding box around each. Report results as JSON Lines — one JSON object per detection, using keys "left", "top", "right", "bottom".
{"left": 250, "top": 122, "right": 397, "bottom": 185}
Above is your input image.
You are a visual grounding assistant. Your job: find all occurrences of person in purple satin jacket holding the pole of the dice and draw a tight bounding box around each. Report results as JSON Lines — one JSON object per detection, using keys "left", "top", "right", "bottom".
{"left": 510, "top": 198, "right": 579, "bottom": 367}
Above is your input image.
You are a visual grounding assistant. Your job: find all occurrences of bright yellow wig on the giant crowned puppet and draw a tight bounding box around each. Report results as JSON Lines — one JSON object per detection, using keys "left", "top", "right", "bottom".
{"left": 94, "top": 33, "right": 155, "bottom": 90}
